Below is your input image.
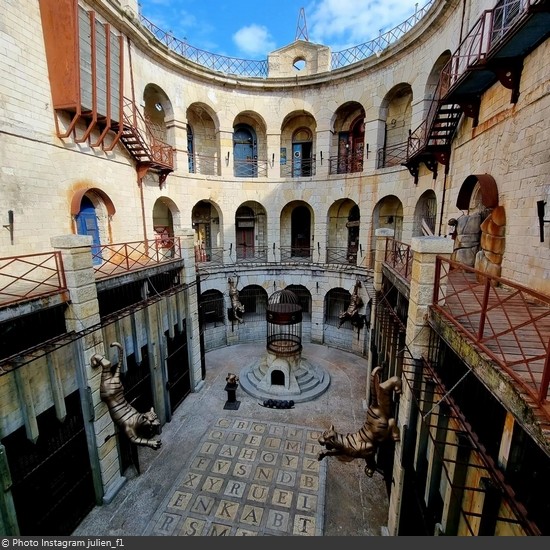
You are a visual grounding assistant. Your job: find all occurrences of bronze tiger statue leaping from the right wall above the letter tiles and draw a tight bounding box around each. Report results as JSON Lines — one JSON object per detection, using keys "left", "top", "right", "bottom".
{"left": 317, "top": 367, "right": 402, "bottom": 477}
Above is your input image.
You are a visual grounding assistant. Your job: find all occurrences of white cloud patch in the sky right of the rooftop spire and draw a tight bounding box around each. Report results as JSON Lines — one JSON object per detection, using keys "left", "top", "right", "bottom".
{"left": 306, "top": 0, "right": 428, "bottom": 51}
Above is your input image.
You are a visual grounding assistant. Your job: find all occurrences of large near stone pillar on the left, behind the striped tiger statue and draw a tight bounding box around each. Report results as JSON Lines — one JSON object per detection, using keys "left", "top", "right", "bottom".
{"left": 51, "top": 235, "right": 126, "bottom": 503}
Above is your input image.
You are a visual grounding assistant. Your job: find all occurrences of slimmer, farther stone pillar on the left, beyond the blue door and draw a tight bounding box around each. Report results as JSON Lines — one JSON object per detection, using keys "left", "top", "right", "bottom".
{"left": 175, "top": 228, "right": 204, "bottom": 391}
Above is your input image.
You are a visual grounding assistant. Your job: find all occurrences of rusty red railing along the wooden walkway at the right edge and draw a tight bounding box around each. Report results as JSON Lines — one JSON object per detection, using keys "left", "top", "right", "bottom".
{"left": 432, "top": 256, "right": 550, "bottom": 413}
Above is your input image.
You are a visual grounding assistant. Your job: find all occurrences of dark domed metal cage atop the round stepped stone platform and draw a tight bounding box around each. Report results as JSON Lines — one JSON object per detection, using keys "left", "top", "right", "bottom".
{"left": 266, "top": 290, "right": 302, "bottom": 357}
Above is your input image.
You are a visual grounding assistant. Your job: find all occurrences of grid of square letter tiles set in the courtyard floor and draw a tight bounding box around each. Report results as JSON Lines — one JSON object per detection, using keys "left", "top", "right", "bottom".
{"left": 143, "top": 417, "right": 326, "bottom": 536}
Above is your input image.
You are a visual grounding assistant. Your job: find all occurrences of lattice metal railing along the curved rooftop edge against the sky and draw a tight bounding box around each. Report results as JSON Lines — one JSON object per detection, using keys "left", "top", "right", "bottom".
{"left": 139, "top": 0, "right": 435, "bottom": 78}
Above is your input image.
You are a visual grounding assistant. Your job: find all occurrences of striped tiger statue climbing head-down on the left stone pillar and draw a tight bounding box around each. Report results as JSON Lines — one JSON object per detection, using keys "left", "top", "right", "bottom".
{"left": 90, "top": 342, "right": 161, "bottom": 450}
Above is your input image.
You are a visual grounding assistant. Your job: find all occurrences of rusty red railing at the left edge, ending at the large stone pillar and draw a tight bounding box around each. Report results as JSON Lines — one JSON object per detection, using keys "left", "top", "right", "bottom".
{"left": 0, "top": 252, "right": 67, "bottom": 307}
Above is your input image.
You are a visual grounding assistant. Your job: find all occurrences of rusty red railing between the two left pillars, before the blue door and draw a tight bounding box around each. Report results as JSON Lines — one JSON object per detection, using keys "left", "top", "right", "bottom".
{"left": 92, "top": 237, "right": 181, "bottom": 280}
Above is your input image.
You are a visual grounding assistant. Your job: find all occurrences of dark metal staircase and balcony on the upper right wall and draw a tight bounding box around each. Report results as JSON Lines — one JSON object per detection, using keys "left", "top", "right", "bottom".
{"left": 403, "top": 0, "right": 550, "bottom": 183}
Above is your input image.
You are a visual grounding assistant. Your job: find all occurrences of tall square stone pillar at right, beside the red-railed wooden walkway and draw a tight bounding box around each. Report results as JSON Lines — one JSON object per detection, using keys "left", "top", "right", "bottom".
{"left": 386, "top": 237, "right": 454, "bottom": 536}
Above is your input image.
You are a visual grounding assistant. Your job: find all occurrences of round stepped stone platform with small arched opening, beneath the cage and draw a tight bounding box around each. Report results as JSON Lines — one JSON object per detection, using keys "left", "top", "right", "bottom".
{"left": 239, "top": 351, "right": 330, "bottom": 403}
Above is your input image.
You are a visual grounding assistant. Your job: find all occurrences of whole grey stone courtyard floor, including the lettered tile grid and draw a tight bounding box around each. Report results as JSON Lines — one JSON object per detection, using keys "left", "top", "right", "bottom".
{"left": 72, "top": 343, "right": 388, "bottom": 537}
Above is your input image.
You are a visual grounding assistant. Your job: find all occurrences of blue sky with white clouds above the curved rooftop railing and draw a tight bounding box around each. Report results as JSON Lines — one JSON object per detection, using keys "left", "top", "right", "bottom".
{"left": 138, "top": 0, "right": 428, "bottom": 60}
